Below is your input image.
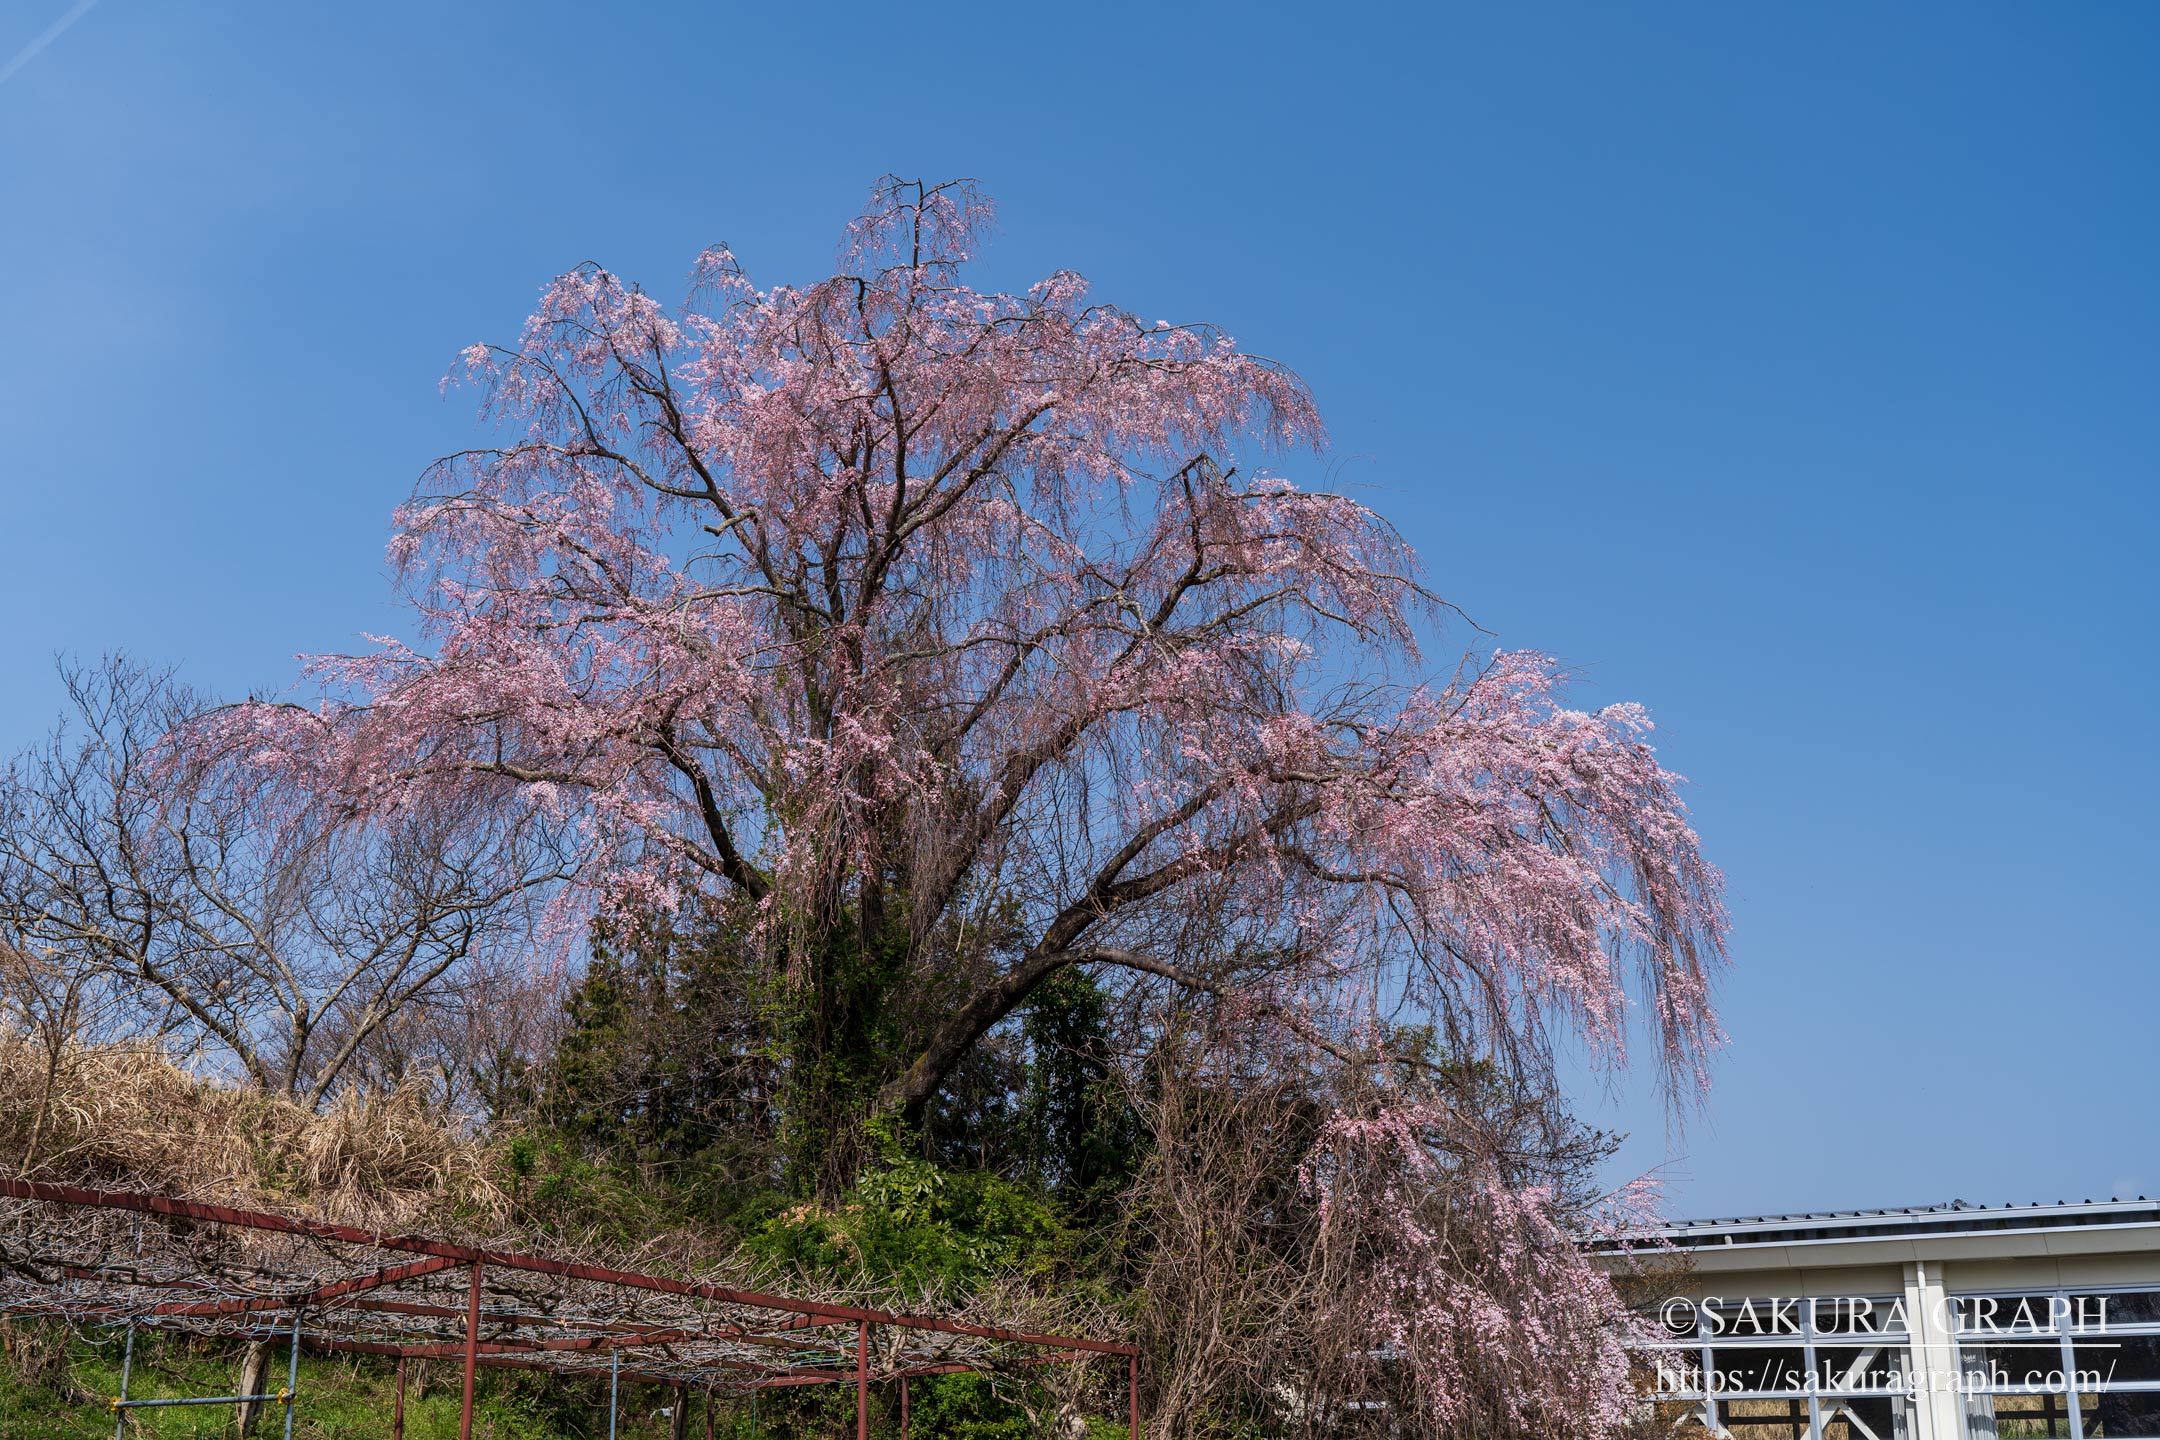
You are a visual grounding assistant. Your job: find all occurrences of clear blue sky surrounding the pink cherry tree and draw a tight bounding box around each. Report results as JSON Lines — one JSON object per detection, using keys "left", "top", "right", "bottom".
{"left": 0, "top": 0, "right": 2160, "bottom": 1213}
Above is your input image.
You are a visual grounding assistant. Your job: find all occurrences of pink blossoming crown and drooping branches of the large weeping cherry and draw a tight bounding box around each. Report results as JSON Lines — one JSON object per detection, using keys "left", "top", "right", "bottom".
{"left": 210, "top": 179, "right": 1726, "bottom": 1434}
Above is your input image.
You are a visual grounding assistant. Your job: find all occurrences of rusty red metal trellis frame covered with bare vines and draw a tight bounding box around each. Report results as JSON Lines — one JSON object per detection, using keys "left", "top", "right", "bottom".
{"left": 0, "top": 1177, "right": 1140, "bottom": 1440}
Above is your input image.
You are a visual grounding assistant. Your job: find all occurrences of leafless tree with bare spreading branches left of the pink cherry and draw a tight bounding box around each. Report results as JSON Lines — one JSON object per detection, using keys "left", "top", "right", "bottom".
{"left": 0, "top": 658, "right": 559, "bottom": 1105}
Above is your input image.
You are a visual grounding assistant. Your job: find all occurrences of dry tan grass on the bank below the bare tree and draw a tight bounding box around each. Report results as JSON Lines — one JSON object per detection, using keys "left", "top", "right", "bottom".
{"left": 0, "top": 1032, "right": 508, "bottom": 1226}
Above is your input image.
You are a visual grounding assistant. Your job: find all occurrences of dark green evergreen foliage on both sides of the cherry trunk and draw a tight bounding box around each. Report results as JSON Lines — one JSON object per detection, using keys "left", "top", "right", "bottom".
{"left": 529, "top": 913, "right": 1145, "bottom": 1243}
